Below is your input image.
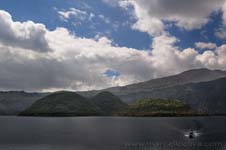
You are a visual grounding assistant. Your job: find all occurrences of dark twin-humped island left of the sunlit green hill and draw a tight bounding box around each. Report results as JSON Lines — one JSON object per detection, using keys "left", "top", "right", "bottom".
{"left": 20, "top": 92, "right": 127, "bottom": 116}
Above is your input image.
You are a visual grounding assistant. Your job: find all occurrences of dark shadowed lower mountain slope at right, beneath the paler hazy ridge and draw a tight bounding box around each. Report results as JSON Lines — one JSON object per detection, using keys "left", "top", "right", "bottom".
{"left": 124, "top": 78, "right": 226, "bottom": 114}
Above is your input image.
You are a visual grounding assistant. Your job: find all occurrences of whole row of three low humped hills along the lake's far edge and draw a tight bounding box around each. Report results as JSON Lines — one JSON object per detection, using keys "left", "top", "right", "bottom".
{"left": 20, "top": 92, "right": 207, "bottom": 117}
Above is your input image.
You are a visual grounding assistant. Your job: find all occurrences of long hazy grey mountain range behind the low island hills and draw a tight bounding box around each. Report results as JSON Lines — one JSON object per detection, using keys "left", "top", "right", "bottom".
{"left": 0, "top": 69, "right": 226, "bottom": 115}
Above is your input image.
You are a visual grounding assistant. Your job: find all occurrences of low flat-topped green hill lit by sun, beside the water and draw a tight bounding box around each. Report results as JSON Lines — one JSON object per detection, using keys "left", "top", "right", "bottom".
{"left": 119, "top": 99, "right": 198, "bottom": 117}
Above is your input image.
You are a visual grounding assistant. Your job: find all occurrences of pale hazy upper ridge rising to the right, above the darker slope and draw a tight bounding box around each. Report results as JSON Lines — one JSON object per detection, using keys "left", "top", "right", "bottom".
{"left": 79, "top": 69, "right": 226, "bottom": 103}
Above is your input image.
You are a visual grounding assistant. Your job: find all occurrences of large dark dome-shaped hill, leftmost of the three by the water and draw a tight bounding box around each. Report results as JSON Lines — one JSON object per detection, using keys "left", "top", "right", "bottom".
{"left": 20, "top": 92, "right": 99, "bottom": 116}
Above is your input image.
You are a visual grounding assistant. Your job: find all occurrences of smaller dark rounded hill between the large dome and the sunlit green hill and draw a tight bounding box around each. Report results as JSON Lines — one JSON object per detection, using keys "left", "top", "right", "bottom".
{"left": 91, "top": 92, "right": 127, "bottom": 115}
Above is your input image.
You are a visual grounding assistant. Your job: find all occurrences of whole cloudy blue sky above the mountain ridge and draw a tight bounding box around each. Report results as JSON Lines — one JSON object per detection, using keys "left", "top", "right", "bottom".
{"left": 0, "top": 0, "right": 226, "bottom": 92}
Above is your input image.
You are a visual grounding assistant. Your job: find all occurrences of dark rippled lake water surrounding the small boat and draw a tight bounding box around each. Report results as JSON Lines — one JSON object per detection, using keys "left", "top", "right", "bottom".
{"left": 0, "top": 117, "right": 226, "bottom": 150}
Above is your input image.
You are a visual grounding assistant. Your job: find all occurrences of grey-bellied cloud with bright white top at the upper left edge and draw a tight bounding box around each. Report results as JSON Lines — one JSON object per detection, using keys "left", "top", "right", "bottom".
{"left": 0, "top": 10, "right": 51, "bottom": 52}
